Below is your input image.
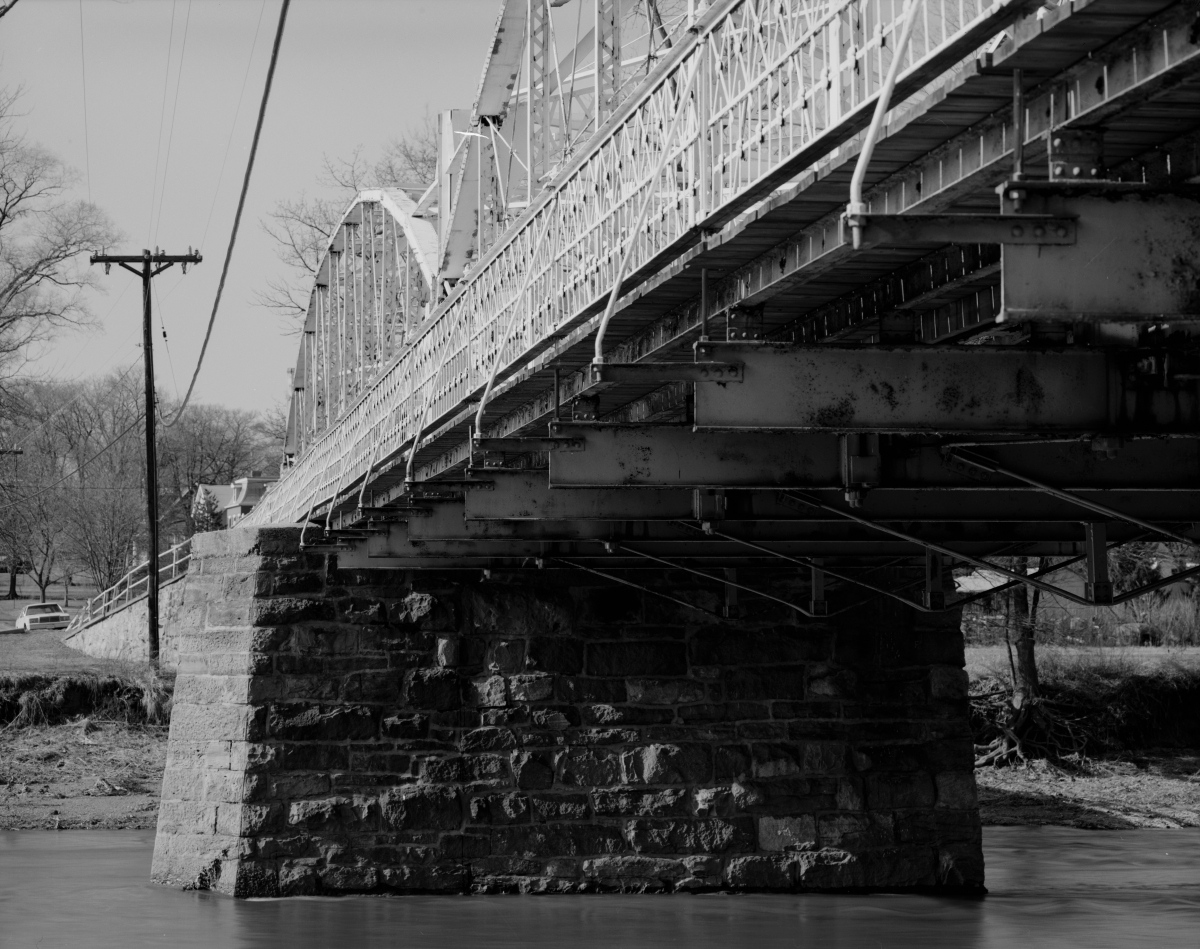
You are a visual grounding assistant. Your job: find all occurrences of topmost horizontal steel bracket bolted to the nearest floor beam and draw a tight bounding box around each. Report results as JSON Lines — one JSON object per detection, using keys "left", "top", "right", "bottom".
{"left": 846, "top": 214, "right": 1075, "bottom": 248}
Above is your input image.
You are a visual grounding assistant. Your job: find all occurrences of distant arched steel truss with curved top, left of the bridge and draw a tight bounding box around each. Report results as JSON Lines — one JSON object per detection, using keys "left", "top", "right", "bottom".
{"left": 286, "top": 191, "right": 437, "bottom": 456}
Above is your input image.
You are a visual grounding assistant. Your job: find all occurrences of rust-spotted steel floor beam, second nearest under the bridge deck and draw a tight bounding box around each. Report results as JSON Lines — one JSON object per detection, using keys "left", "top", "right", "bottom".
{"left": 695, "top": 343, "right": 1200, "bottom": 434}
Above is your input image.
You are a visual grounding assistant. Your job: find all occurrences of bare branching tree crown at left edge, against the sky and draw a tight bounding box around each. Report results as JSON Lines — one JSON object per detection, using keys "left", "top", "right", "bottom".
{"left": 0, "top": 91, "right": 118, "bottom": 376}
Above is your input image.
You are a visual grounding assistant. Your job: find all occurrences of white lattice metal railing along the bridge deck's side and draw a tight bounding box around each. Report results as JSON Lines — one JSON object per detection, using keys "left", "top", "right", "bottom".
{"left": 248, "top": 0, "right": 1020, "bottom": 523}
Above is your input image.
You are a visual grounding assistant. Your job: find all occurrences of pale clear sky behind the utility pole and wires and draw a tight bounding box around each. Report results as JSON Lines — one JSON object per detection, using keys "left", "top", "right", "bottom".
{"left": 0, "top": 0, "right": 500, "bottom": 410}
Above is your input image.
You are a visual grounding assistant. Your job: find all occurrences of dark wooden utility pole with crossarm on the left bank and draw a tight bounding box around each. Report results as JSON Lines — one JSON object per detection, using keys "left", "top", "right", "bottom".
{"left": 91, "top": 247, "right": 203, "bottom": 668}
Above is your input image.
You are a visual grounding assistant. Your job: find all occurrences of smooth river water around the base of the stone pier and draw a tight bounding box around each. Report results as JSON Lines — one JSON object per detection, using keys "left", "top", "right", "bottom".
{"left": 0, "top": 828, "right": 1200, "bottom": 949}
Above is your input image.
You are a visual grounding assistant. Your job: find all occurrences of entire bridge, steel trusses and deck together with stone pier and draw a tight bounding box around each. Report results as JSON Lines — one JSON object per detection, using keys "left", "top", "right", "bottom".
{"left": 155, "top": 0, "right": 1200, "bottom": 895}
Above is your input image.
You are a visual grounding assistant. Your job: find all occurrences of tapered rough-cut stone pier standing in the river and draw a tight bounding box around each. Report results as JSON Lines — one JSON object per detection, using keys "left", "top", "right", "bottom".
{"left": 154, "top": 528, "right": 983, "bottom": 896}
